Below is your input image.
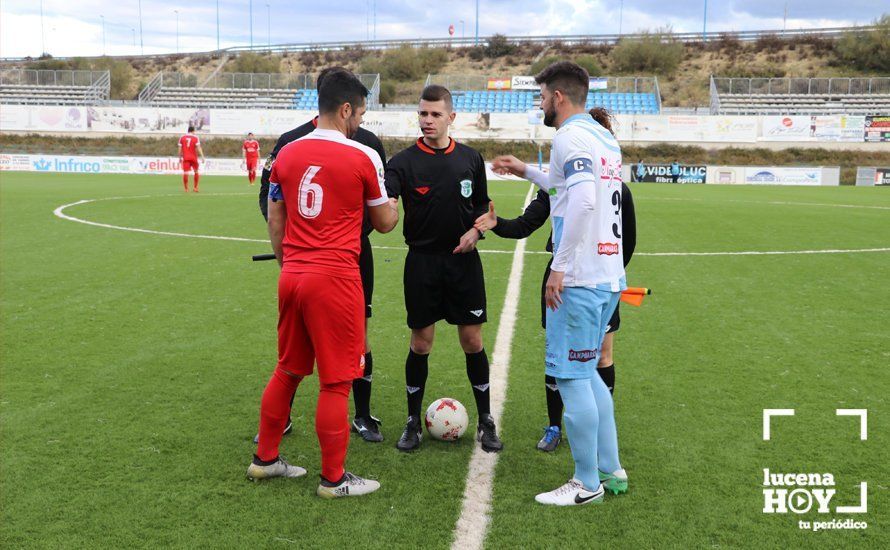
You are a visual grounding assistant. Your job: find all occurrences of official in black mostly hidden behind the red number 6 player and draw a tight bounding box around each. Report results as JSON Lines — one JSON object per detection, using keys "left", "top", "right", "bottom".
{"left": 253, "top": 67, "right": 386, "bottom": 443}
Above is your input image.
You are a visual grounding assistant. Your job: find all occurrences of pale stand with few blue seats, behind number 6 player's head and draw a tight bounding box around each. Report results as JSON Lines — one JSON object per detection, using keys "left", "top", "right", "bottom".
{"left": 139, "top": 72, "right": 380, "bottom": 111}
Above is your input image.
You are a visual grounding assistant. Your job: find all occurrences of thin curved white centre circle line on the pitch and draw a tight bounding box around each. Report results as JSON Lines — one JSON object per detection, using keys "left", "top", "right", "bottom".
{"left": 53, "top": 193, "right": 890, "bottom": 256}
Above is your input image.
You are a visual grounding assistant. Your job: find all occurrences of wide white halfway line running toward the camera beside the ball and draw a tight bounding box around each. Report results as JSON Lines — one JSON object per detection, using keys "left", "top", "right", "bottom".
{"left": 451, "top": 186, "right": 535, "bottom": 550}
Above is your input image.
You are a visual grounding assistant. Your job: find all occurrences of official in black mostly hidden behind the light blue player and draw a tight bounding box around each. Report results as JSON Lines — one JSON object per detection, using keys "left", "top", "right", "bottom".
{"left": 475, "top": 107, "right": 637, "bottom": 452}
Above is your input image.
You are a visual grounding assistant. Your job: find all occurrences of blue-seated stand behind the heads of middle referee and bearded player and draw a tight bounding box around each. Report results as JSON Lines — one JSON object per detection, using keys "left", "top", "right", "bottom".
{"left": 426, "top": 74, "right": 661, "bottom": 114}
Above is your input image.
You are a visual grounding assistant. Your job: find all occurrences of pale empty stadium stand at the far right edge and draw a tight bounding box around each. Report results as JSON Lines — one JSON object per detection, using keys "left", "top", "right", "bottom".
{"left": 711, "top": 76, "right": 890, "bottom": 115}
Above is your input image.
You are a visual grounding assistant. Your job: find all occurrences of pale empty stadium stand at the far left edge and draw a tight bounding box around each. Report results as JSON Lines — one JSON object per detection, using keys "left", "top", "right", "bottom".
{"left": 0, "top": 69, "right": 111, "bottom": 105}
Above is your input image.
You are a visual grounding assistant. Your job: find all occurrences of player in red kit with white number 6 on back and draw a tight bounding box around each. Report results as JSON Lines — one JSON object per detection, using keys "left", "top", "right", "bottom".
{"left": 247, "top": 72, "right": 399, "bottom": 498}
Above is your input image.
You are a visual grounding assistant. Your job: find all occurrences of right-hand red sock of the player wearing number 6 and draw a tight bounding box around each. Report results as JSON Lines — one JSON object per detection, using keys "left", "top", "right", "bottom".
{"left": 316, "top": 380, "right": 352, "bottom": 482}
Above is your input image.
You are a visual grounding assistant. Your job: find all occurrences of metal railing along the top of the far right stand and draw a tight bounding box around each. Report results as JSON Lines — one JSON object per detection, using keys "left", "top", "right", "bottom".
{"left": 711, "top": 76, "right": 890, "bottom": 96}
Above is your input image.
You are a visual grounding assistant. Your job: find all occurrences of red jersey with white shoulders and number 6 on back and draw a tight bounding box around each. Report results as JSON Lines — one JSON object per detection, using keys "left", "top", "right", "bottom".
{"left": 269, "top": 130, "right": 388, "bottom": 279}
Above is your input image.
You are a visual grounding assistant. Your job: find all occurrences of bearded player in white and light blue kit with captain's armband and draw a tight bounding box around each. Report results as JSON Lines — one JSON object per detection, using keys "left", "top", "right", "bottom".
{"left": 494, "top": 62, "right": 627, "bottom": 506}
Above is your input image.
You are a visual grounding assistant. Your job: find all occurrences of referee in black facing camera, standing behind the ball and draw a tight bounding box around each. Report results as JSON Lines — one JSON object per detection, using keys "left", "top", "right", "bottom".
{"left": 386, "top": 85, "right": 503, "bottom": 452}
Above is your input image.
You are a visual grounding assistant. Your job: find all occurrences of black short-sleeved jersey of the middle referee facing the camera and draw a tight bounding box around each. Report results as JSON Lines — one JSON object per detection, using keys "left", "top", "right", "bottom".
{"left": 386, "top": 138, "right": 489, "bottom": 254}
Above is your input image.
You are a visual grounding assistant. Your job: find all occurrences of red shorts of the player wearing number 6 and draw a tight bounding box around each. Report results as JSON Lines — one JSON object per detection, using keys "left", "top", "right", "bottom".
{"left": 278, "top": 272, "right": 365, "bottom": 384}
